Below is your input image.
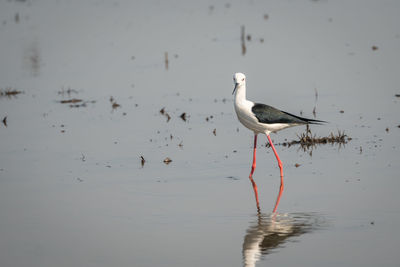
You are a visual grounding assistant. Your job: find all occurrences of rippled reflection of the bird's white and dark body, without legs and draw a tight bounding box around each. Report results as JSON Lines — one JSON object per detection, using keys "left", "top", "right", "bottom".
{"left": 243, "top": 213, "right": 325, "bottom": 266}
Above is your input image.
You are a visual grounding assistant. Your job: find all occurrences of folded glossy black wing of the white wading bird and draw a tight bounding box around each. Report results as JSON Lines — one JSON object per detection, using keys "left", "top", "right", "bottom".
{"left": 251, "top": 103, "right": 325, "bottom": 124}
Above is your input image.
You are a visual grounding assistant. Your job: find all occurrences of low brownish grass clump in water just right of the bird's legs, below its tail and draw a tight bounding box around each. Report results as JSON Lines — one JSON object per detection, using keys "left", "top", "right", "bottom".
{"left": 267, "top": 125, "right": 352, "bottom": 151}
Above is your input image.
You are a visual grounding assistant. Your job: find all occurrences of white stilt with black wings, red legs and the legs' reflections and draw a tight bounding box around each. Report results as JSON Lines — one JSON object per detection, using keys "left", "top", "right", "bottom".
{"left": 232, "top": 72, "right": 325, "bottom": 213}
